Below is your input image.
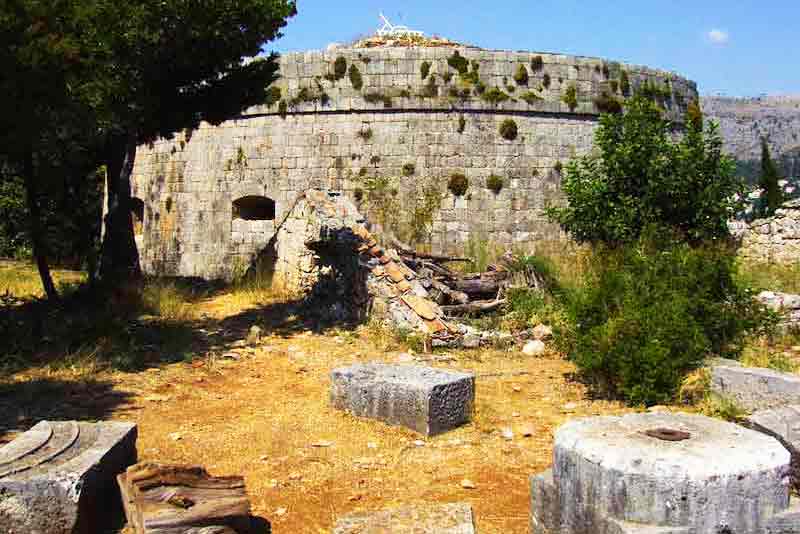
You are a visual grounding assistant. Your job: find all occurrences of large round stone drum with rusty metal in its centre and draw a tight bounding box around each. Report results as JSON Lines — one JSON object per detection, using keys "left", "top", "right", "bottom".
{"left": 531, "top": 413, "right": 800, "bottom": 534}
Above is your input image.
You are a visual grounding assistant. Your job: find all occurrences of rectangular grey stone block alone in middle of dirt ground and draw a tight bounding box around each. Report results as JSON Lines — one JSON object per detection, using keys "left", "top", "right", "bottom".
{"left": 331, "top": 363, "right": 475, "bottom": 436}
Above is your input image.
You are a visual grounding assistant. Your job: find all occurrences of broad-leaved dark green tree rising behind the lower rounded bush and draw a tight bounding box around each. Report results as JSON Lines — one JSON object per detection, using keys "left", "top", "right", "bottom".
{"left": 546, "top": 96, "right": 743, "bottom": 246}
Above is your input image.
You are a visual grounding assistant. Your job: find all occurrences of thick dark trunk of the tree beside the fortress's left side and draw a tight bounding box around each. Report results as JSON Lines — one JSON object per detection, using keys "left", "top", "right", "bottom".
{"left": 100, "top": 135, "right": 142, "bottom": 286}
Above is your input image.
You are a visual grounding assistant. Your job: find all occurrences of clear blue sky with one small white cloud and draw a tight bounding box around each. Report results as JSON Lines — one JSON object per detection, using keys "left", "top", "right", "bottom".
{"left": 268, "top": 0, "right": 800, "bottom": 96}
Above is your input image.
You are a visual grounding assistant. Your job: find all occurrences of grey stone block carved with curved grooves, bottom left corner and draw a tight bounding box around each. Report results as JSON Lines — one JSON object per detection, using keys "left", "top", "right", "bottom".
{"left": 0, "top": 421, "right": 136, "bottom": 534}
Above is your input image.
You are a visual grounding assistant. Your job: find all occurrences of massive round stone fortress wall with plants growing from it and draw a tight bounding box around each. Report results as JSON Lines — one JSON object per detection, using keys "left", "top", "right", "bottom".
{"left": 132, "top": 36, "right": 697, "bottom": 279}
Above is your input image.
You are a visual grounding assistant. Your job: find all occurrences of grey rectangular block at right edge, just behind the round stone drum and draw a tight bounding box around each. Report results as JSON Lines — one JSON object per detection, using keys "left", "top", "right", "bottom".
{"left": 711, "top": 359, "right": 800, "bottom": 411}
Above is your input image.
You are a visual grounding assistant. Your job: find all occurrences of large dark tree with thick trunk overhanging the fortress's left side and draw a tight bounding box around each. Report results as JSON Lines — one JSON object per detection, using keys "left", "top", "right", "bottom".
{"left": 84, "top": 0, "right": 296, "bottom": 283}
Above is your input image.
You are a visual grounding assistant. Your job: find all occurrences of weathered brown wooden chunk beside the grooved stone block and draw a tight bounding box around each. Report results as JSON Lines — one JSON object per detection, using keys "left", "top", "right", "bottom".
{"left": 117, "top": 463, "right": 251, "bottom": 534}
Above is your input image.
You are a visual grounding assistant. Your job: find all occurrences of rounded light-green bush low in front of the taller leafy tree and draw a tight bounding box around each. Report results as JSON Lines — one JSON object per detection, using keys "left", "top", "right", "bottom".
{"left": 567, "top": 231, "right": 768, "bottom": 404}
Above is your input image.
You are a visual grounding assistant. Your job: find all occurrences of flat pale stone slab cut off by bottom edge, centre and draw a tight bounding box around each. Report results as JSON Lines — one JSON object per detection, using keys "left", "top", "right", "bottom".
{"left": 333, "top": 503, "right": 477, "bottom": 534}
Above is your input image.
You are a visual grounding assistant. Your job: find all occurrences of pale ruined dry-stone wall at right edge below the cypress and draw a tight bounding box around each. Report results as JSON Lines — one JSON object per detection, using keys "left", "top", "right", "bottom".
{"left": 733, "top": 199, "right": 800, "bottom": 264}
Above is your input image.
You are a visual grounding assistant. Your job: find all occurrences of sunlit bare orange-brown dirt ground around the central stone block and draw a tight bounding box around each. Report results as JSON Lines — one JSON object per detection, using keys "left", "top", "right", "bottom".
{"left": 0, "top": 296, "right": 626, "bottom": 534}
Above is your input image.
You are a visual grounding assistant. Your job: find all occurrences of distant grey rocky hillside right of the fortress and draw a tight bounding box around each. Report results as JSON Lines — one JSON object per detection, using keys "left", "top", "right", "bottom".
{"left": 701, "top": 95, "right": 800, "bottom": 182}
